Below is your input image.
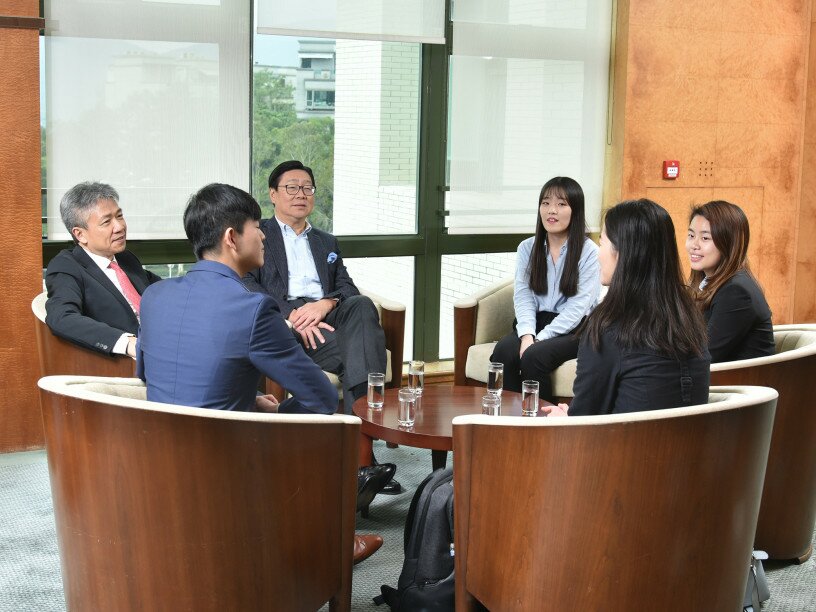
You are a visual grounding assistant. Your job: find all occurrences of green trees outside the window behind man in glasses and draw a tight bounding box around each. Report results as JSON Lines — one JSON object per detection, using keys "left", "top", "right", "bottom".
{"left": 252, "top": 68, "right": 334, "bottom": 231}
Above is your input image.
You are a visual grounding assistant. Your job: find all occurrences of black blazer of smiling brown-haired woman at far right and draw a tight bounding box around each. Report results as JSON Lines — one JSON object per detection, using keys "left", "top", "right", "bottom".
{"left": 703, "top": 270, "right": 776, "bottom": 363}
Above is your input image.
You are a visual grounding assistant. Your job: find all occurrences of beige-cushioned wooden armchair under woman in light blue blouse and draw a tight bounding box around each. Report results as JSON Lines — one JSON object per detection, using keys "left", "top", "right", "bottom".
{"left": 453, "top": 279, "right": 577, "bottom": 399}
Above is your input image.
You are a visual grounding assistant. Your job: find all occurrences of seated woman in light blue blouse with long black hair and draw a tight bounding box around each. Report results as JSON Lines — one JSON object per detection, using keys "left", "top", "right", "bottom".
{"left": 490, "top": 176, "right": 600, "bottom": 401}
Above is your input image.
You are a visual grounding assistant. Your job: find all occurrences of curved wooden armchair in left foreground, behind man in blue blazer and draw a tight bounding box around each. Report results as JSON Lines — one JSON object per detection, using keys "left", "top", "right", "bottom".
{"left": 39, "top": 376, "right": 360, "bottom": 611}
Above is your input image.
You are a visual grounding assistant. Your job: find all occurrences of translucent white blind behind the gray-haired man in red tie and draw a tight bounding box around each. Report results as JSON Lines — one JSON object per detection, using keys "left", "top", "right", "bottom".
{"left": 45, "top": 0, "right": 250, "bottom": 239}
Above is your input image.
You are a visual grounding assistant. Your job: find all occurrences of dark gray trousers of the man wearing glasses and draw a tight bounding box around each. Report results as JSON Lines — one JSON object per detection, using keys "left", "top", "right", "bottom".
{"left": 289, "top": 295, "right": 386, "bottom": 414}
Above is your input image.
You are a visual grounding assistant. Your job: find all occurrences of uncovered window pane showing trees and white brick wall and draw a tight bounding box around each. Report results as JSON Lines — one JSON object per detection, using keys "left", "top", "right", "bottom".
{"left": 252, "top": 35, "right": 421, "bottom": 235}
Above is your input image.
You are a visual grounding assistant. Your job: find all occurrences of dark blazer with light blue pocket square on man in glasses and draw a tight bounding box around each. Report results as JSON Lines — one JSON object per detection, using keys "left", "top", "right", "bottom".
{"left": 243, "top": 217, "right": 360, "bottom": 318}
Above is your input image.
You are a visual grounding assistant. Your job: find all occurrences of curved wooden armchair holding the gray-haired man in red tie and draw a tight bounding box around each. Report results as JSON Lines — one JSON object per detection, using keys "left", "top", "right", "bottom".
{"left": 31, "top": 291, "right": 136, "bottom": 378}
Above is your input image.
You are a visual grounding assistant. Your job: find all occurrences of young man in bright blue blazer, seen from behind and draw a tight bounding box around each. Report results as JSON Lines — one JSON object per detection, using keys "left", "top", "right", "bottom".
{"left": 136, "top": 184, "right": 382, "bottom": 562}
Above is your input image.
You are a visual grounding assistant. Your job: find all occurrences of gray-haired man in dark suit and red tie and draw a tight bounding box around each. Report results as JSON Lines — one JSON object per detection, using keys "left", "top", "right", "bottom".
{"left": 45, "top": 183, "right": 161, "bottom": 357}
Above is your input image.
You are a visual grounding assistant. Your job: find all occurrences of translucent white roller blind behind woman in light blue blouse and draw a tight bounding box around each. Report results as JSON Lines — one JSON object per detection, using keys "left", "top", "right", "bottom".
{"left": 446, "top": 0, "right": 611, "bottom": 233}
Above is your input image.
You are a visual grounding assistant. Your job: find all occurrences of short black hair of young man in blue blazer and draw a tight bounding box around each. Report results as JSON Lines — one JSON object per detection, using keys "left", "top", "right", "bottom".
{"left": 184, "top": 183, "right": 261, "bottom": 259}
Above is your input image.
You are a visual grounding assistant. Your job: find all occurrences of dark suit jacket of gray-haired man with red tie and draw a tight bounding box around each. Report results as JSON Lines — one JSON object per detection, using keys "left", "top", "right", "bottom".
{"left": 45, "top": 245, "right": 161, "bottom": 354}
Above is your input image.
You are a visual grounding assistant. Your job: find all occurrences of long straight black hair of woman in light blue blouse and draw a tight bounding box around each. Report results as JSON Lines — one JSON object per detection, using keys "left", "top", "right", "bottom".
{"left": 527, "top": 176, "right": 586, "bottom": 297}
